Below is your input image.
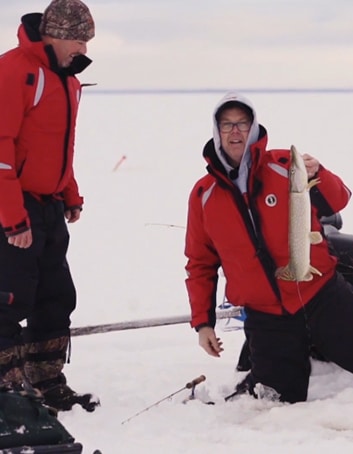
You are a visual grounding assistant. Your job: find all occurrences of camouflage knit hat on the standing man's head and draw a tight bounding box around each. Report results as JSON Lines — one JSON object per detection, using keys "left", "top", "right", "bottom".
{"left": 39, "top": 0, "right": 94, "bottom": 42}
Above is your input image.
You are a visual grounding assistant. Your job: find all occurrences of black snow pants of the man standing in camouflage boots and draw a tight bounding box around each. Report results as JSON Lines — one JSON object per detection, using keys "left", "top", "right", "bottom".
{"left": 0, "top": 193, "right": 76, "bottom": 350}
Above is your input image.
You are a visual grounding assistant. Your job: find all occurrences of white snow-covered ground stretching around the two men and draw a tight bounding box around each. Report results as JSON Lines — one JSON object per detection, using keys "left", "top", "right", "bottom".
{"left": 59, "top": 93, "right": 353, "bottom": 454}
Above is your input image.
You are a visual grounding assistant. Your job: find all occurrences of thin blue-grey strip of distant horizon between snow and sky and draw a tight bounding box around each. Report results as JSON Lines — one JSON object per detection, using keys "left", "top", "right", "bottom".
{"left": 82, "top": 88, "right": 353, "bottom": 95}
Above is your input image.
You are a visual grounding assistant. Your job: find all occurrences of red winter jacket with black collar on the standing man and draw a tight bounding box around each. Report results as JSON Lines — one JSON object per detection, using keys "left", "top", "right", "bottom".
{"left": 0, "top": 13, "right": 91, "bottom": 235}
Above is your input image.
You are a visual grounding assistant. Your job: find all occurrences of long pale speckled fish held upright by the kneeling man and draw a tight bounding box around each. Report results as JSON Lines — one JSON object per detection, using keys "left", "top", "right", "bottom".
{"left": 275, "top": 145, "right": 323, "bottom": 282}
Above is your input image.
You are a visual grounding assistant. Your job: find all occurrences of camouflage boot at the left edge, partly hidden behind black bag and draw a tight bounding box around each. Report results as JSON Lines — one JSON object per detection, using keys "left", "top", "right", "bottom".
{"left": 0, "top": 345, "right": 24, "bottom": 390}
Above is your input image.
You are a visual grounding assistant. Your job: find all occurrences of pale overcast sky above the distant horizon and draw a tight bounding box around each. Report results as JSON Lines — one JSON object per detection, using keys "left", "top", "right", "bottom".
{"left": 0, "top": 0, "right": 353, "bottom": 89}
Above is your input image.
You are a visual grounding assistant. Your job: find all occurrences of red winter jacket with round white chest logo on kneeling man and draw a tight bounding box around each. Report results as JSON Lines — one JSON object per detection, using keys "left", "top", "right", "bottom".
{"left": 185, "top": 126, "right": 350, "bottom": 328}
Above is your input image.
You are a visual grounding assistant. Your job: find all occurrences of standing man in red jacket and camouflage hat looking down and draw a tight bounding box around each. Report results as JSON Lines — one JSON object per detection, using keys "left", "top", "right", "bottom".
{"left": 0, "top": 0, "right": 94, "bottom": 410}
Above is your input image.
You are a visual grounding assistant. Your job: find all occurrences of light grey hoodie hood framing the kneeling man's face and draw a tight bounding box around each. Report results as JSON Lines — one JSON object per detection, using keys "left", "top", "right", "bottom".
{"left": 213, "top": 92, "right": 260, "bottom": 193}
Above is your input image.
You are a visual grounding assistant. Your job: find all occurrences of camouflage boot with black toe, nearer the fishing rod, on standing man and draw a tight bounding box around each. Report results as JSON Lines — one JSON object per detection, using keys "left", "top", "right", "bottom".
{"left": 24, "top": 336, "right": 99, "bottom": 412}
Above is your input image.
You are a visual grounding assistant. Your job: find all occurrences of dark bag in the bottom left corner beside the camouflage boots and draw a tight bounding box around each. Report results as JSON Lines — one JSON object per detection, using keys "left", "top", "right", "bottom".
{"left": 0, "top": 387, "right": 82, "bottom": 453}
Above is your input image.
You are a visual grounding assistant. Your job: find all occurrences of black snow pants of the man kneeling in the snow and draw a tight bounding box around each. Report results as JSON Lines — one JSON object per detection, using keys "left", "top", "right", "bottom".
{"left": 244, "top": 273, "right": 353, "bottom": 403}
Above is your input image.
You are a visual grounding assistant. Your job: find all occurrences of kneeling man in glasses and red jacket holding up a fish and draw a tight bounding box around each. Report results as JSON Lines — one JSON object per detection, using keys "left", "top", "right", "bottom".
{"left": 185, "top": 93, "right": 353, "bottom": 403}
